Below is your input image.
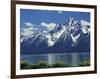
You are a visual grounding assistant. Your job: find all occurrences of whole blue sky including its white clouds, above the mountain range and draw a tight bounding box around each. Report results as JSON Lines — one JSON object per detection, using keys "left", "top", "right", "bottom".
{"left": 20, "top": 9, "right": 90, "bottom": 34}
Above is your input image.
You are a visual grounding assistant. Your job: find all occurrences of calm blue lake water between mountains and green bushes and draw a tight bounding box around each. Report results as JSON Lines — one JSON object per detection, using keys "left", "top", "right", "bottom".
{"left": 21, "top": 52, "right": 90, "bottom": 65}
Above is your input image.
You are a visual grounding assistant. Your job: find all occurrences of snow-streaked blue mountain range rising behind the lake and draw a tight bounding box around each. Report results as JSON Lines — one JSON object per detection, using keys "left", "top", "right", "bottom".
{"left": 21, "top": 17, "right": 90, "bottom": 54}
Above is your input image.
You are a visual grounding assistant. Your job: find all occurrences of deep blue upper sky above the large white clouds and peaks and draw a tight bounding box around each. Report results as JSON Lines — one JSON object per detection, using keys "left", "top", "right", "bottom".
{"left": 20, "top": 9, "right": 90, "bottom": 27}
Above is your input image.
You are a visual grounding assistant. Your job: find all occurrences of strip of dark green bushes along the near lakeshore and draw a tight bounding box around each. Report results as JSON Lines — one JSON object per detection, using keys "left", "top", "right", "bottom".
{"left": 20, "top": 60, "right": 90, "bottom": 69}
